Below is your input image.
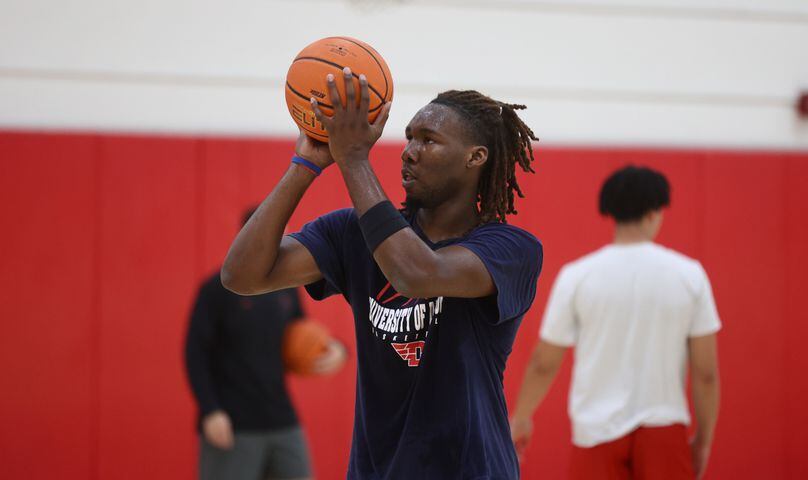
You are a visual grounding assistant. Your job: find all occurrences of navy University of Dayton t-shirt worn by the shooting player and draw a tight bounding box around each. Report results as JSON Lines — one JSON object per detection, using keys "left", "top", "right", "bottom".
{"left": 292, "top": 209, "right": 542, "bottom": 480}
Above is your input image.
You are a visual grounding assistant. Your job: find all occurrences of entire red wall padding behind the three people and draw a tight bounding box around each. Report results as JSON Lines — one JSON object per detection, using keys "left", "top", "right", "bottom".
{"left": 0, "top": 132, "right": 808, "bottom": 480}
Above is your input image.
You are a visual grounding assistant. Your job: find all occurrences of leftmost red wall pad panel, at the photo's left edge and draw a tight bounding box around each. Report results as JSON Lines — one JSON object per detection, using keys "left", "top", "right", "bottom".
{"left": 0, "top": 134, "right": 99, "bottom": 479}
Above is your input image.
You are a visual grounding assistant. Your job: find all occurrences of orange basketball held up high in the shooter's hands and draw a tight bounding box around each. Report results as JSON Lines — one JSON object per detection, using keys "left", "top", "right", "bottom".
{"left": 286, "top": 37, "right": 393, "bottom": 142}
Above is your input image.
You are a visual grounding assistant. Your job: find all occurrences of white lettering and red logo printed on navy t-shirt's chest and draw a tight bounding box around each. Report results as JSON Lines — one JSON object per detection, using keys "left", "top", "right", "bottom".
{"left": 368, "top": 282, "right": 443, "bottom": 367}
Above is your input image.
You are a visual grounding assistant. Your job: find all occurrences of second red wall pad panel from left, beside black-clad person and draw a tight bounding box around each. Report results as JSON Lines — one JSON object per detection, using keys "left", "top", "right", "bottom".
{"left": 98, "top": 137, "right": 198, "bottom": 479}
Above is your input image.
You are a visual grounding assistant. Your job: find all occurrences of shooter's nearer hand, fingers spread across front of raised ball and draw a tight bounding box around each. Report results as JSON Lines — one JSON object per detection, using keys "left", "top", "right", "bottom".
{"left": 311, "top": 67, "right": 390, "bottom": 166}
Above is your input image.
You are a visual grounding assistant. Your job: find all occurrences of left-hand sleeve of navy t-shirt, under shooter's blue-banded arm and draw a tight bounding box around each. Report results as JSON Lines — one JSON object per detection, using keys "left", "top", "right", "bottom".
{"left": 290, "top": 208, "right": 355, "bottom": 300}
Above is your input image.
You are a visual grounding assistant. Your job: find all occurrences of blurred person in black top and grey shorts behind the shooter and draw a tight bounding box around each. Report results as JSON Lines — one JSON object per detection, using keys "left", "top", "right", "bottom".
{"left": 185, "top": 212, "right": 344, "bottom": 480}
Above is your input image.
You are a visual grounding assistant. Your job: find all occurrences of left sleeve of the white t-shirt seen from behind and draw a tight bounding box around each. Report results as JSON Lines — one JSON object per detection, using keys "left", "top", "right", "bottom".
{"left": 539, "top": 267, "right": 578, "bottom": 347}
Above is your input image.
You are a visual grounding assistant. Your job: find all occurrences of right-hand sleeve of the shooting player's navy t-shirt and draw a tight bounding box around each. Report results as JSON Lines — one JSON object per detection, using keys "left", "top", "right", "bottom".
{"left": 458, "top": 224, "right": 543, "bottom": 323}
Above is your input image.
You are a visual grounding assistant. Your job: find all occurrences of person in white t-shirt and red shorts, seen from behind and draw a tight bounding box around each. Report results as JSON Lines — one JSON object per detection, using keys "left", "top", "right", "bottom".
{"left": 511, "top": 166, "right": 721, "bottom": 480}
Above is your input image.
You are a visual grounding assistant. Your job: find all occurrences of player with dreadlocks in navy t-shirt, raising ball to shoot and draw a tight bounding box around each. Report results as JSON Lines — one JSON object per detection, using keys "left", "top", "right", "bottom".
{"left": 222, "top": 69, "right": 542, "bottom": 480}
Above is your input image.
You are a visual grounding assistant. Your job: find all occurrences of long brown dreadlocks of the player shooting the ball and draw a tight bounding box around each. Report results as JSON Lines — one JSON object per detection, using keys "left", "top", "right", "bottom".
{"left": 430, "top": 90, "right": 538, "bottom": 224}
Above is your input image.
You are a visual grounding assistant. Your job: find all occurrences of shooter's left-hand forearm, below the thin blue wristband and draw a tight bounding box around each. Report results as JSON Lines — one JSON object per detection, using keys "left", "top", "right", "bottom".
{"left": 221, "top": 164, "right": 314, "bottom": 295}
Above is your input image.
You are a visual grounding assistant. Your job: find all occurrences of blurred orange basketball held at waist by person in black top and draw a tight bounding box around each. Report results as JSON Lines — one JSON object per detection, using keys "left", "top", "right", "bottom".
{"left": 281, "top": 320, "right": 331, "bottom": 375}
